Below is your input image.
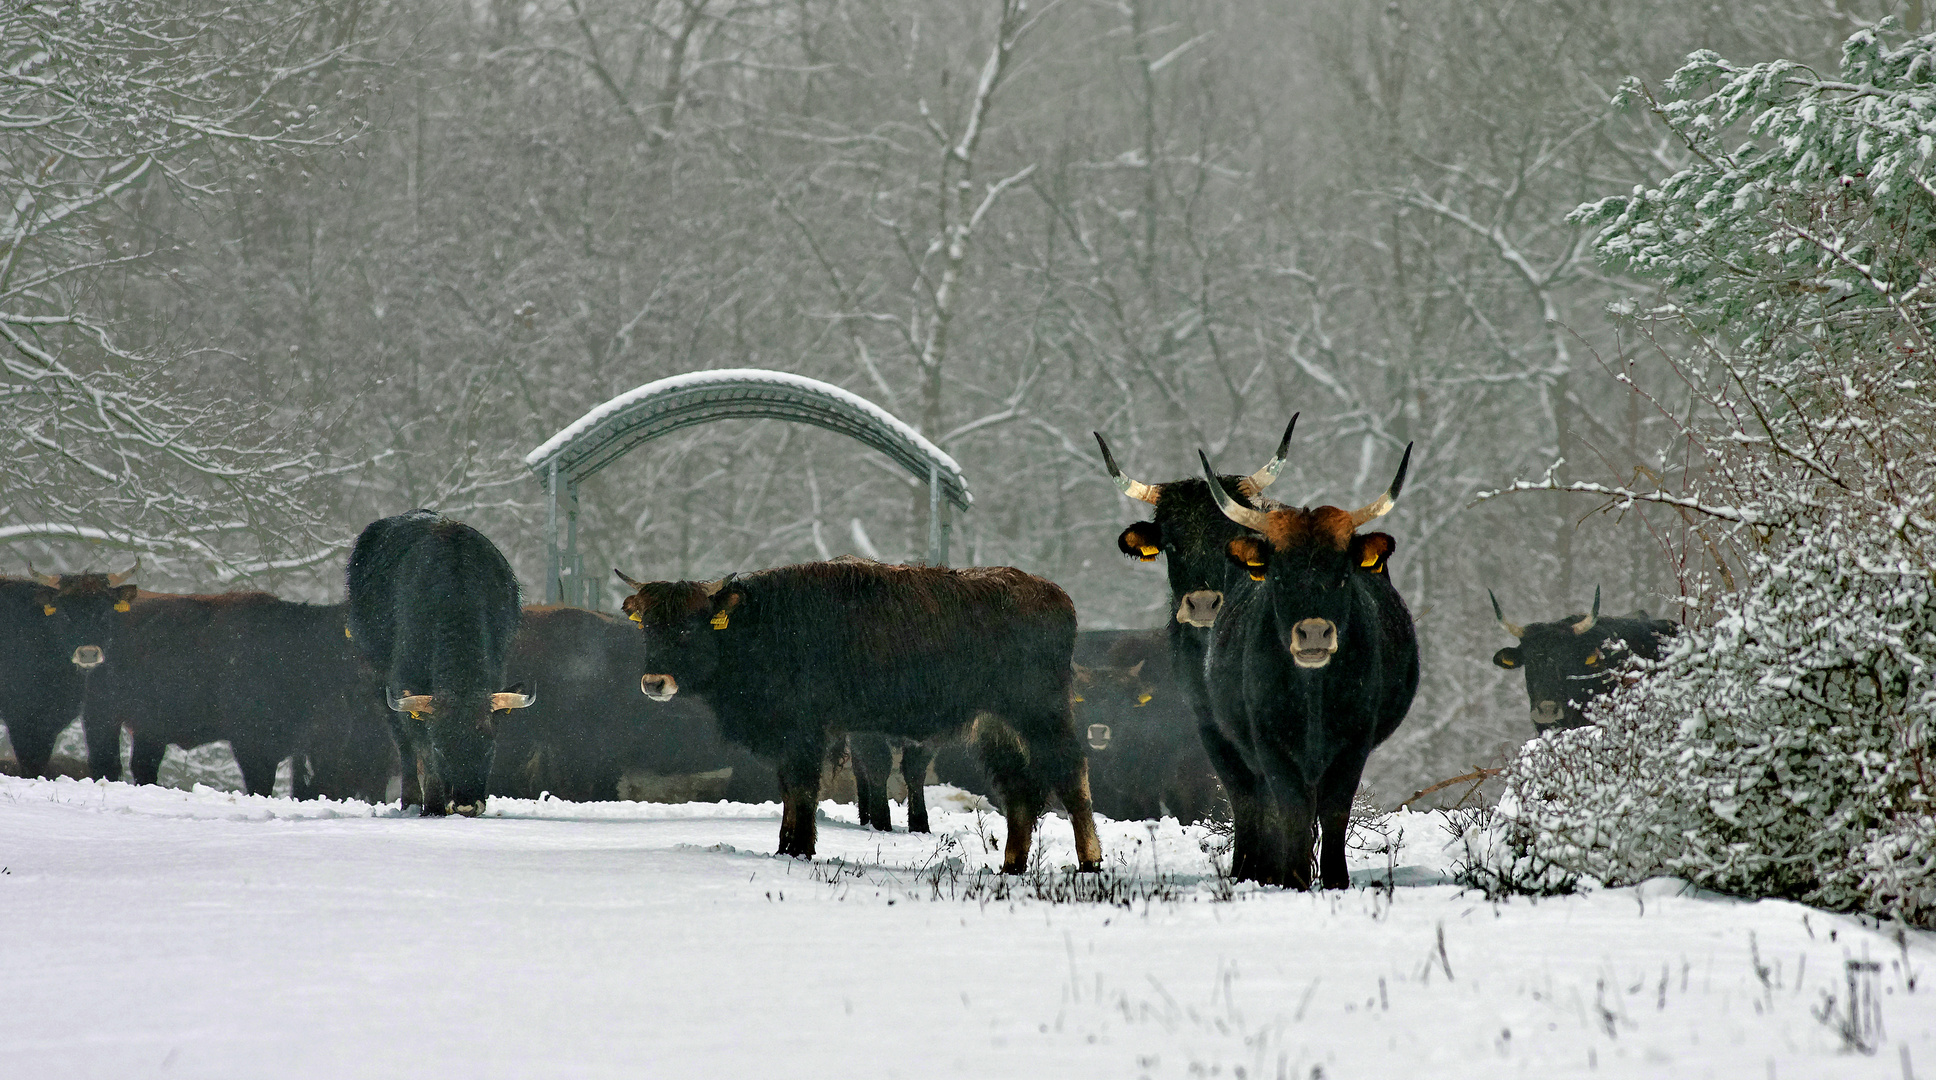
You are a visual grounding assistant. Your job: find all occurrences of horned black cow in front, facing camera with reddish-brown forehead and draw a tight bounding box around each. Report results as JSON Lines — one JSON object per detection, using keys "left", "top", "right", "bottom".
{"left": 1202, "top": 445, "right": 1419, "bottom": 888}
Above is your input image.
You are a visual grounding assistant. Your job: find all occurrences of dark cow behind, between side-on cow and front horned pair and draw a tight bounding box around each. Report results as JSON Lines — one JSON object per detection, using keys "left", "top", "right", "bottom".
{"left": 1074, "top": 629, "right": 1224, "bottom": 823}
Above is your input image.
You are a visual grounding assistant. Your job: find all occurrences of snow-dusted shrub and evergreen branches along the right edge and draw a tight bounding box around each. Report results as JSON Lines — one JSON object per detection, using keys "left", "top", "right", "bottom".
{"left": 1485, "top": 31, "right": 1936, "bottom": 925}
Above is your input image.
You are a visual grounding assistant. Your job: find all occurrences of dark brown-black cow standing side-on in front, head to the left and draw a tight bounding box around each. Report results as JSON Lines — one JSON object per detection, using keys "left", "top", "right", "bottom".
{"left": 620, "top": 561, "right": 1102, "bottom": 873}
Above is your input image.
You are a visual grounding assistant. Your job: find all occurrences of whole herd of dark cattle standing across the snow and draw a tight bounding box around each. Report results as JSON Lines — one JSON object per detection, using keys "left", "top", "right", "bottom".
{"left": 0, "top": 427, "right": 1673, "bottom": 888}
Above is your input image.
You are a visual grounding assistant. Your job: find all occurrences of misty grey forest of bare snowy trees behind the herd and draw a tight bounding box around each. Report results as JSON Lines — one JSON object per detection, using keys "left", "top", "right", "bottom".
{"left": 0, "top": 0, "right": 1922, "bottom": 801}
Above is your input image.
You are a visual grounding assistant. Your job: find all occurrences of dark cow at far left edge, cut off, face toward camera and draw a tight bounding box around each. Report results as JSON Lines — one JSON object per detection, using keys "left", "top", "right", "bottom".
{"left": 0, "top": 559, "right": 141, "bottom": 776}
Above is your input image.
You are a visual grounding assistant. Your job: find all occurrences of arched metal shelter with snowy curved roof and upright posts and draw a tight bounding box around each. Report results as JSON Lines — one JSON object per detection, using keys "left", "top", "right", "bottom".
{"left": 525, "top": 368, "right": 974, "bottom": 604}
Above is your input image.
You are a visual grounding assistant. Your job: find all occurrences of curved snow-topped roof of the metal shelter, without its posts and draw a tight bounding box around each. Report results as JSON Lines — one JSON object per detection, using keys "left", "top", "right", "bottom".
{"left": 525, "top": 368, "right": 974, "bottom": 511}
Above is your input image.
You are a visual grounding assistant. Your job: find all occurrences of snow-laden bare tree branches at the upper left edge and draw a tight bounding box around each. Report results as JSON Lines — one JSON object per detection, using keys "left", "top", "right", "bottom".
{"left": 0, "top": 0, "right": 365, "bottom": 577}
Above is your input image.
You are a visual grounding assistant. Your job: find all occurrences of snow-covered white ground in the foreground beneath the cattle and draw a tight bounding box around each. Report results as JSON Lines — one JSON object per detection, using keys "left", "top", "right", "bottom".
{"left": 0, "top": 776, "right": 1936, "bottom": 1080}
